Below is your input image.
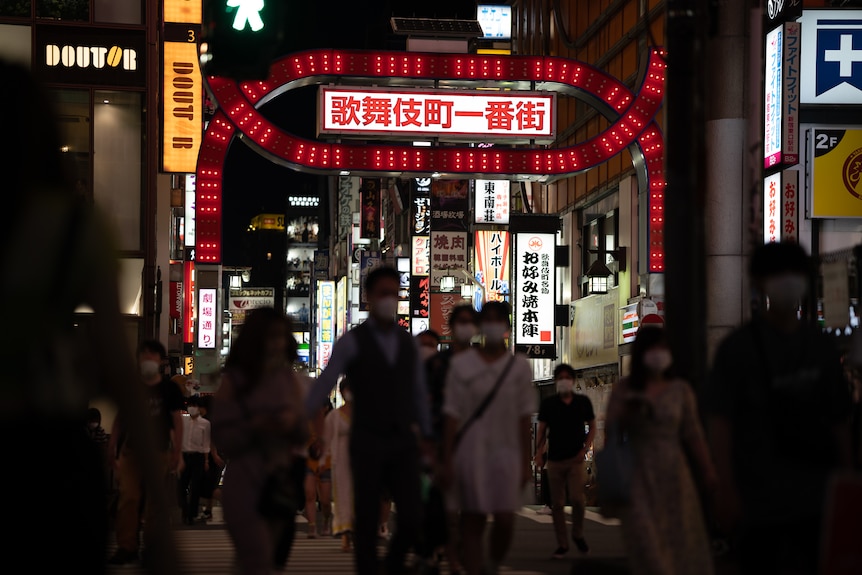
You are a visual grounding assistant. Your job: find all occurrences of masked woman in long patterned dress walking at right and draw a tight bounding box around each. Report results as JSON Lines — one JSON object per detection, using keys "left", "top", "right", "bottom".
{"left": 598, "top": 326, "right": 718, "bottom": 575}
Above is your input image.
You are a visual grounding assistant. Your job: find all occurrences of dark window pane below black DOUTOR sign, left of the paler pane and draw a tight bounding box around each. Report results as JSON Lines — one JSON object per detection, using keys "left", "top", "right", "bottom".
{"left": 51, "top": 90, "right": 92, "bottom": 197}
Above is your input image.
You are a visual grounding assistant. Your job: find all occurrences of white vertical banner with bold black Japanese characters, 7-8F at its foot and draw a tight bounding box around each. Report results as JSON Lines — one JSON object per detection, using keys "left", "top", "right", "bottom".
{"left": 512, "top": 232, "right": 556, "bottom": 358}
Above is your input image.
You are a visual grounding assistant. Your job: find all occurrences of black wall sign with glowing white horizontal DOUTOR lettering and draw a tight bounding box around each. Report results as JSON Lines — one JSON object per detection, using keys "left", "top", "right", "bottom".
{"left": 33, "top": 26, "right": 147, "bottom": 87}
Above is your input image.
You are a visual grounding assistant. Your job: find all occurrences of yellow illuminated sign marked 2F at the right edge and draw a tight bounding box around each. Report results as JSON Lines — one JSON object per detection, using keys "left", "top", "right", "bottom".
{"left": 810, "top": 128, "right": 862, "bottom": 218}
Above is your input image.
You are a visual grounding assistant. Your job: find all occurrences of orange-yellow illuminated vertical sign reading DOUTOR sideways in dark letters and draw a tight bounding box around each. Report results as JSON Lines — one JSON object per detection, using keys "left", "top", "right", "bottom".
{"left": 162, "top": 42, "right": 203, "bottom": 173}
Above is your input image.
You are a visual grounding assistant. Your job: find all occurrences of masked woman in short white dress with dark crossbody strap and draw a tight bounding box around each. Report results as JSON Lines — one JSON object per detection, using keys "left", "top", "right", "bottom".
{"left": 443, "top": 302, "right": 536, "bottom": 575}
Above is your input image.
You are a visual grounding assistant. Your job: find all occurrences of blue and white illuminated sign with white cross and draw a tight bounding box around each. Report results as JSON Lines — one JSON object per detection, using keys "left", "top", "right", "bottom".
{"left": 802, "top": 10, "right": 862, "bottom": 105}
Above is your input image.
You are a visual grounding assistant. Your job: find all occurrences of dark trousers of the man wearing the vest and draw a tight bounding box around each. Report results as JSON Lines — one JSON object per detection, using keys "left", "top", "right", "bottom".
{"left": 350, "top": 428, "right": 422, "bottom": 575}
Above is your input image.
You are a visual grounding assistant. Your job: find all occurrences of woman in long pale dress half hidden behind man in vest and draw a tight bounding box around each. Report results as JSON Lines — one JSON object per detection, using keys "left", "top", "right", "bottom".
{"left": 323, "top": 379, "right": 354, "bottom": 553}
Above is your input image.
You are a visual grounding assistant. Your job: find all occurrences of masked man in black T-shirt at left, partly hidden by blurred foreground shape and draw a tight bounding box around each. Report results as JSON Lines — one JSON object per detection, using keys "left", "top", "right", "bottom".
{"left": 109, "top": 340, "right": 184, "bottom": 565}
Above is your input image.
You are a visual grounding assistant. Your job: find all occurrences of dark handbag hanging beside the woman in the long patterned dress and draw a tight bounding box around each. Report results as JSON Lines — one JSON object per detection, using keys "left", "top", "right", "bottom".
{"left": 595, "top": 423, "right": 635, "bottom": 516}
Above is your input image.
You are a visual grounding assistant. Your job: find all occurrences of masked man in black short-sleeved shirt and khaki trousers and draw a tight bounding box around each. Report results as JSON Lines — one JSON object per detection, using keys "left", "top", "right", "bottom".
{"left": 536, "top": 364, "right": 596, "bottom": 559}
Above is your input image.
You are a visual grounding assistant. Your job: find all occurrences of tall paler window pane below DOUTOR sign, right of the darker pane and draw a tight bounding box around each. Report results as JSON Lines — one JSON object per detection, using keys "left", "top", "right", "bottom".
{"left": 93, "top": 90, "right": 144, "bottom": 251}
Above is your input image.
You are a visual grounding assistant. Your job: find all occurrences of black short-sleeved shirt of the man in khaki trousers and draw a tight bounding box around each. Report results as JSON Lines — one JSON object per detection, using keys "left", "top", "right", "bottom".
{"left": 539, "top": 393, "right": 596, "bottom": 461}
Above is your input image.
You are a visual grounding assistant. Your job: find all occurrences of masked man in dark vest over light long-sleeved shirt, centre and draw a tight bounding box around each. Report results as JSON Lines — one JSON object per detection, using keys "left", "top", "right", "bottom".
{"left": 306, "top": 267, "right": 432, "bottom": 575}
